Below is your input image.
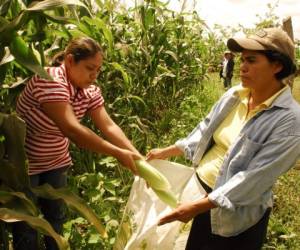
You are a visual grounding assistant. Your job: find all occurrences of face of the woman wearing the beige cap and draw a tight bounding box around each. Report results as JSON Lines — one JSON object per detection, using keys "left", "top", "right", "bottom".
{"left": 240, "top": 50, "right": 282, "bottom": 89}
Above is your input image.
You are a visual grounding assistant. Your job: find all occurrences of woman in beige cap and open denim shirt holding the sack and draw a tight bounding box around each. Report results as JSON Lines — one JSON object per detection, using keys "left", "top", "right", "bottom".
{"left": 147, "top": 28, "right": 300, "bottom": 250}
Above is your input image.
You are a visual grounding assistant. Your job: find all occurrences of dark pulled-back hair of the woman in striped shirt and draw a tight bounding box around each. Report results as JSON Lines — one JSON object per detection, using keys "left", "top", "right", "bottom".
{"left": 51, "top": 37, "right": 103, "bottom": 66}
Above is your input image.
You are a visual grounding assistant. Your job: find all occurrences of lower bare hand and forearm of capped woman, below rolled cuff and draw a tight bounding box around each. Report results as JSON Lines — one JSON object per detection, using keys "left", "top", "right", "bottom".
{"left": 158, "top": 197, "right": 216, "bottom": 225}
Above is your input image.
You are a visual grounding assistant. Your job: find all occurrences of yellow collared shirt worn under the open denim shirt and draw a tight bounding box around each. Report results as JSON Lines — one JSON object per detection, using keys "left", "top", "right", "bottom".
{"left": 197, "top": 86, "right": 288, "bottom": 188}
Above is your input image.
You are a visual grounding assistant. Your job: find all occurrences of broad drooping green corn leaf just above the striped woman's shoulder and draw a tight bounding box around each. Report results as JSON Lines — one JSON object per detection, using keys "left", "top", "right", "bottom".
{"left": 9, "top": 34, "right": 51, "bottom": 79}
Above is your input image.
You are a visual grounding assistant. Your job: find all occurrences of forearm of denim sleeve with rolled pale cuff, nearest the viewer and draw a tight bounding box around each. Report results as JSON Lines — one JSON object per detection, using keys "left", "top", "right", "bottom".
{"left": 208, "top": 135, "right": 300, "bottom": 211}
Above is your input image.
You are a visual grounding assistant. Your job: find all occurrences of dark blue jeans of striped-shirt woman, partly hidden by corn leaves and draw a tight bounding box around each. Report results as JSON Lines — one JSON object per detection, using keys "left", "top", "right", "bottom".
{"left": 12, "top": 166, "right": 69, "bottom": 250}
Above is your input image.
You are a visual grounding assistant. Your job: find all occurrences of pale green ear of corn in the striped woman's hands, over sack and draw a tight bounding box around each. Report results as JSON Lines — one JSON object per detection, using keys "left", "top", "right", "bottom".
{"left": 135, "top": 160, "right": 171, "bottom": 190}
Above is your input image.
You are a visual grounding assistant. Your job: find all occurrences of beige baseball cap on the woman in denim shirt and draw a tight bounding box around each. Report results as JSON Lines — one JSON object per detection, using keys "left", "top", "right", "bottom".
{"left": 227, "top": 28, "right": 295, "bottom": 62}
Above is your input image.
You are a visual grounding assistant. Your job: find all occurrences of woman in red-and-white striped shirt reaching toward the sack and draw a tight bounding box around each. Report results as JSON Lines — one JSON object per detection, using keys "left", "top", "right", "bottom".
{"left": 13, "top": 37, "right": 142, "bottom": 250}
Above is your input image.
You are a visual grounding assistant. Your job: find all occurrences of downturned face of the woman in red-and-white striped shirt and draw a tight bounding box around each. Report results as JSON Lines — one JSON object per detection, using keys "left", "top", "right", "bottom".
{"left": 65, "top": 52, "right": 103, "bottom": 88}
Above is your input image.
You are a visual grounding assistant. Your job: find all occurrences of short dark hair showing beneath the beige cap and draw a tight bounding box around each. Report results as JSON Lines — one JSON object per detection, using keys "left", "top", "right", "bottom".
{"left": 259, "top": 50, "right": 297, "bottom": 80}
